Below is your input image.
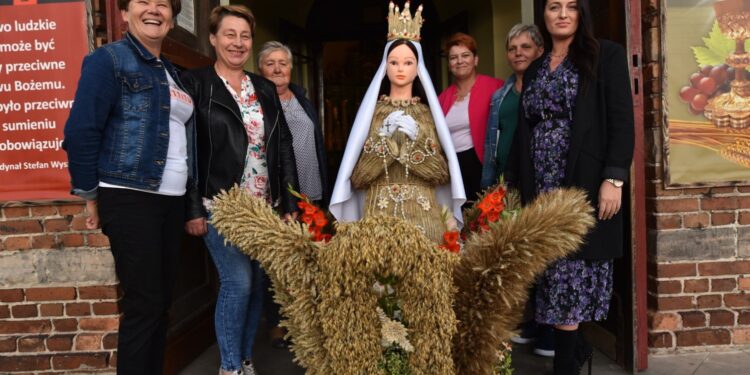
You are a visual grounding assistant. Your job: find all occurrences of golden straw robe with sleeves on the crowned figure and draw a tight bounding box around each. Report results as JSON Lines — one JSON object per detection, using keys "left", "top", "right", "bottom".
{"left": 351, "top": 97, "right": 450, "bottom": 243}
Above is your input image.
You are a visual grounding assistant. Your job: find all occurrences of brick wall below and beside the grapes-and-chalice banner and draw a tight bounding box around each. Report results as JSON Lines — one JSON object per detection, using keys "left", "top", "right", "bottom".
{"left": 642, "top": 0, "right": 750, "bottom": 352}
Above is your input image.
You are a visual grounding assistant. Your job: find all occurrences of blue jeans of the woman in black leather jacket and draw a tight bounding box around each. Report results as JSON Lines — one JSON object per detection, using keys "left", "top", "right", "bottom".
{"left": 203, "top": 219, "right": 265, "bottom": 371}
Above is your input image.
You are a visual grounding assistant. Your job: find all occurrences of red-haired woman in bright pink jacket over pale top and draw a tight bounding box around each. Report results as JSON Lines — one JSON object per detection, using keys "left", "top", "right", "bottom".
{"left": 438, "top": 33, "right": 503, "bottom": 204}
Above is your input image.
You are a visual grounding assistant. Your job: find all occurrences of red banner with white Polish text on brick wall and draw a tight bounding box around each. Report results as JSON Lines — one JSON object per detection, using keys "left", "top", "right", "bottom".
{"left": 0, "top": 0, "right": 88, "bottom": 201}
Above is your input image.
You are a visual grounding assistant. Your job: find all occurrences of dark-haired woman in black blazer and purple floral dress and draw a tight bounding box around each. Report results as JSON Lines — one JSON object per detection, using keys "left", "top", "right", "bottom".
{"left": 506, "top": 0, "right": 634, "bottom": 374}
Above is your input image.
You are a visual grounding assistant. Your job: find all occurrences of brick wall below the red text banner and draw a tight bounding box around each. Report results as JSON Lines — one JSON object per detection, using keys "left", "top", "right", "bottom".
{"left": 0, "top": 202, "right": 119, "bottom": 374}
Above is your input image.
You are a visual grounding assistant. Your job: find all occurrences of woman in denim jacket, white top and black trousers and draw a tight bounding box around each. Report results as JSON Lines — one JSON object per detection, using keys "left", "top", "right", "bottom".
{"left": 65, "top": 0, "right": 195, "bottom": 375}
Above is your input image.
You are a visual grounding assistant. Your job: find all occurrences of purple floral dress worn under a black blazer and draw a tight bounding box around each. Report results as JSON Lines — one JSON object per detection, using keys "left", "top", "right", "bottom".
{"left": 523, "top": 55, "right": 612, "bottom": 325}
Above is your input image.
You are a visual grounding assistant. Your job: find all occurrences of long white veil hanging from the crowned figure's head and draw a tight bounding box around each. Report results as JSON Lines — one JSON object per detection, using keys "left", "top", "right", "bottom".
{"left": 329, "top": 41, "right": 466, "bottom": 228}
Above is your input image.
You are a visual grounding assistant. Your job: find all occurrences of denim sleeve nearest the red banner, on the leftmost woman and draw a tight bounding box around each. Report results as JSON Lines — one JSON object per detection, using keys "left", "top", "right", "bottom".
{"left": 63, "top": 48, "right": 119, "bottom": 200}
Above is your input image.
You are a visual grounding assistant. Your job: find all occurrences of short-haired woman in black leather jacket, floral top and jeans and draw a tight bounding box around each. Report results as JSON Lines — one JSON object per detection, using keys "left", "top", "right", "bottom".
{"left": 183, "top": 5, "right": 299, "bottom": 374}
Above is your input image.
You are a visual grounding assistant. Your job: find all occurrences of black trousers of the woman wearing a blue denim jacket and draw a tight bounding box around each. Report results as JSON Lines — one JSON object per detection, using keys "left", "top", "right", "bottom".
{"left": 98, "top": 188, "right": 185, "bottom": 375}
